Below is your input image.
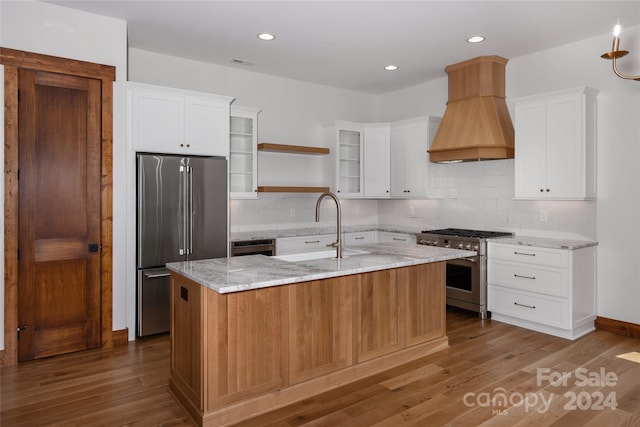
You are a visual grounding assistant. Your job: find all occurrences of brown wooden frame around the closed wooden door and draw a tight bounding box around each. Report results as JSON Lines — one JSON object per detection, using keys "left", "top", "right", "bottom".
{"left": 0, "top": 47, "right": 116, "bottom": 367}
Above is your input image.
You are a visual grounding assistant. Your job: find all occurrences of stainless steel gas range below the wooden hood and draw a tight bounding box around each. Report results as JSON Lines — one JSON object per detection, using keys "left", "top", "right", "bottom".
{"left": 417, "top": 228, "right": 513, "bottom": 319}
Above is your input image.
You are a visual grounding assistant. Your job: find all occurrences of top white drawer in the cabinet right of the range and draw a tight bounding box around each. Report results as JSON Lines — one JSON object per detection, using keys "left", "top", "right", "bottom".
{"left": 487, "top": 242, "right": 569, "bottom": 267}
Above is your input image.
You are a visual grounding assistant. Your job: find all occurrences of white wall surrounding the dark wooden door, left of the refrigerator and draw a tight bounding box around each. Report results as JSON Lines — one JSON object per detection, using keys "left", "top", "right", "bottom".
{"left": 0, "top": 0, "right": 127, "bottom": 349}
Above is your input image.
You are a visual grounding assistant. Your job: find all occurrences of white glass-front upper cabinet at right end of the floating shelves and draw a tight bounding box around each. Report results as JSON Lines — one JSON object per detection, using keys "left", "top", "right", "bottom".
{"left": 325, "top": 121, "right": 364, "bottom": 198}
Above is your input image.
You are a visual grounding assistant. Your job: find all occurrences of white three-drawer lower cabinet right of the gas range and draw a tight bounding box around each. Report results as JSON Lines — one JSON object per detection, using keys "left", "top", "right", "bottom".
{"left": 487, "top": 242, "right": 596, "bottom": 339}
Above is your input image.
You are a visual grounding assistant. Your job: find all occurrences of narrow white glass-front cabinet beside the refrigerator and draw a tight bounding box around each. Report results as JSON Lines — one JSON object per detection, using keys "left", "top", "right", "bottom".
{"left": 229, "top": 106, "right": 260, "bottom": 199}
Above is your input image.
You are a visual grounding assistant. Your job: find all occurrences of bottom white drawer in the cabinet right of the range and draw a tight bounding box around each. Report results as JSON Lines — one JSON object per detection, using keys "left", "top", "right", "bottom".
{"left": 487, "top": 285, "right": 569, "bottom": 329}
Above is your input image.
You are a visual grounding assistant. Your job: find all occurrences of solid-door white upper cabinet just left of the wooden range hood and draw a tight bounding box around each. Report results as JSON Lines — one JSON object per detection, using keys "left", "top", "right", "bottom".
{"left": 391, "top": 116, "right": 440, "bottom": 198}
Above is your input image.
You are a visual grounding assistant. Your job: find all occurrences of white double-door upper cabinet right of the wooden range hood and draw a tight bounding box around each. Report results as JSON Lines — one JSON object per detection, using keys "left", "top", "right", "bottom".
{"left": 513, "top": 87, "right": 598, "bottom": 200}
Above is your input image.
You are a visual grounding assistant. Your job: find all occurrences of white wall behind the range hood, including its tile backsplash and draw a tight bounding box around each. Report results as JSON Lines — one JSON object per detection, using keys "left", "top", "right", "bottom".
{"left": 377, "top": 27, "right": 640, "bottom": 323}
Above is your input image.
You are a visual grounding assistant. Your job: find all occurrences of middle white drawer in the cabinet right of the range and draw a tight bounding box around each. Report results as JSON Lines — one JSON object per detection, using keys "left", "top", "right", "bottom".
{"left": 487, "top": 259, "right": 569, "bottom": 297}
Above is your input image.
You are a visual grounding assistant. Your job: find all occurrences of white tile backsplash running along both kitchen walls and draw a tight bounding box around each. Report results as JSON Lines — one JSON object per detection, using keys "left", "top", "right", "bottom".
{"left": 230, "top": 160, "right": 597, "bottom": 240}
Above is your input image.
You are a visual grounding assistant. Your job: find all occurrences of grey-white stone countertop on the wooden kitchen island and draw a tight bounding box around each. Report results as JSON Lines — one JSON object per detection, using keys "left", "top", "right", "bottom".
{"left": 167, "top": 243, "right": 476, "bottom": 294}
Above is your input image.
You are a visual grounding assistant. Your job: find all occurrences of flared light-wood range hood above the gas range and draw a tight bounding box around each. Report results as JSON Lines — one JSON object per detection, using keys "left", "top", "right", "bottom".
{"left": 429, "top": 56, "right": 514, "bottom": 163}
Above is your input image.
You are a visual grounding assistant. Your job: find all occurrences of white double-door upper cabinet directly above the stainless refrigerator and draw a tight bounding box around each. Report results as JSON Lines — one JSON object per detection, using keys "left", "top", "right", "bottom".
{"left": 127, "top": 83, "right": 233, "bottom": 157}
